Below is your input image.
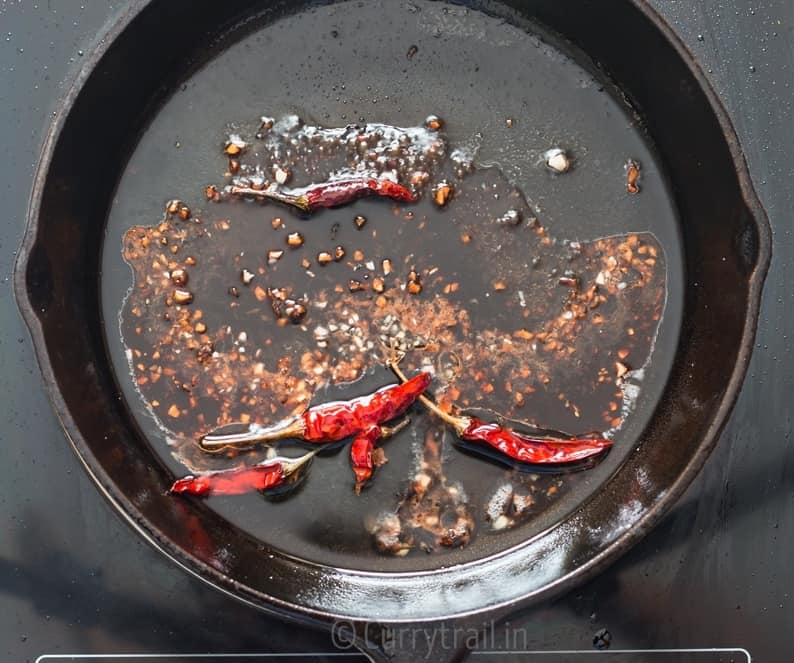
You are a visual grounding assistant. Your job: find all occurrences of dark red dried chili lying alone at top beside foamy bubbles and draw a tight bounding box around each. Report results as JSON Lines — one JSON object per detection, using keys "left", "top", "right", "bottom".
{"left": 227, "top": 177, "right": 416, "bottom": 212}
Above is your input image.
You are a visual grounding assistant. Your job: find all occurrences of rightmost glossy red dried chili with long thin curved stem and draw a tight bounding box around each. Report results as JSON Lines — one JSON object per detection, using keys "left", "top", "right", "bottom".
{"left": 389, "top": 359, "right": 612, "bottom": 465}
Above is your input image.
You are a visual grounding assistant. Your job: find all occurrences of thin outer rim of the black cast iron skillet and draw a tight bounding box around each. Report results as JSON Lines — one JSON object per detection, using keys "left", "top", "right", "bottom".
{"left": 14, "top": 0, "right": 772, "bottom": 624}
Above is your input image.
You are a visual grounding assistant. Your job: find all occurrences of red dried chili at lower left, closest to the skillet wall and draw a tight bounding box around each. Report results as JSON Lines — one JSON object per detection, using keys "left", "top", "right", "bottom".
{"left": 170, "top": 450, "right": 318, "bottom": 496}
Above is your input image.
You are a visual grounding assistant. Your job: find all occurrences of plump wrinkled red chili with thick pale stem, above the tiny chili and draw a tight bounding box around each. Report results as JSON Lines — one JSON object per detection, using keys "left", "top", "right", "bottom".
{"left": 199, "top": 373, "right": 430, "bottom": 452}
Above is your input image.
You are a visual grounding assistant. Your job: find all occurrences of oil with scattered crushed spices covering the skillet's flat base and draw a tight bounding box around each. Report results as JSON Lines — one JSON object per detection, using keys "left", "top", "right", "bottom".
{"left": 97, "top": 3, "right": 682, "bottom": 570}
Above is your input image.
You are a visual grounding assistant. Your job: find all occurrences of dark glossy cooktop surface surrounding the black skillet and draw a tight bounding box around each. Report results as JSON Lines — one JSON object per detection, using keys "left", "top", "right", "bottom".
{"left": 0, "top": 0, "right": 794, "bottom": 661}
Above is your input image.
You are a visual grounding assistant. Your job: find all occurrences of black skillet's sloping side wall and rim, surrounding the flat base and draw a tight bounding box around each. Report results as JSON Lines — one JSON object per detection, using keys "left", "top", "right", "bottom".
{"left": 15, "top": 0, "right": 771, "bottom": 660}
